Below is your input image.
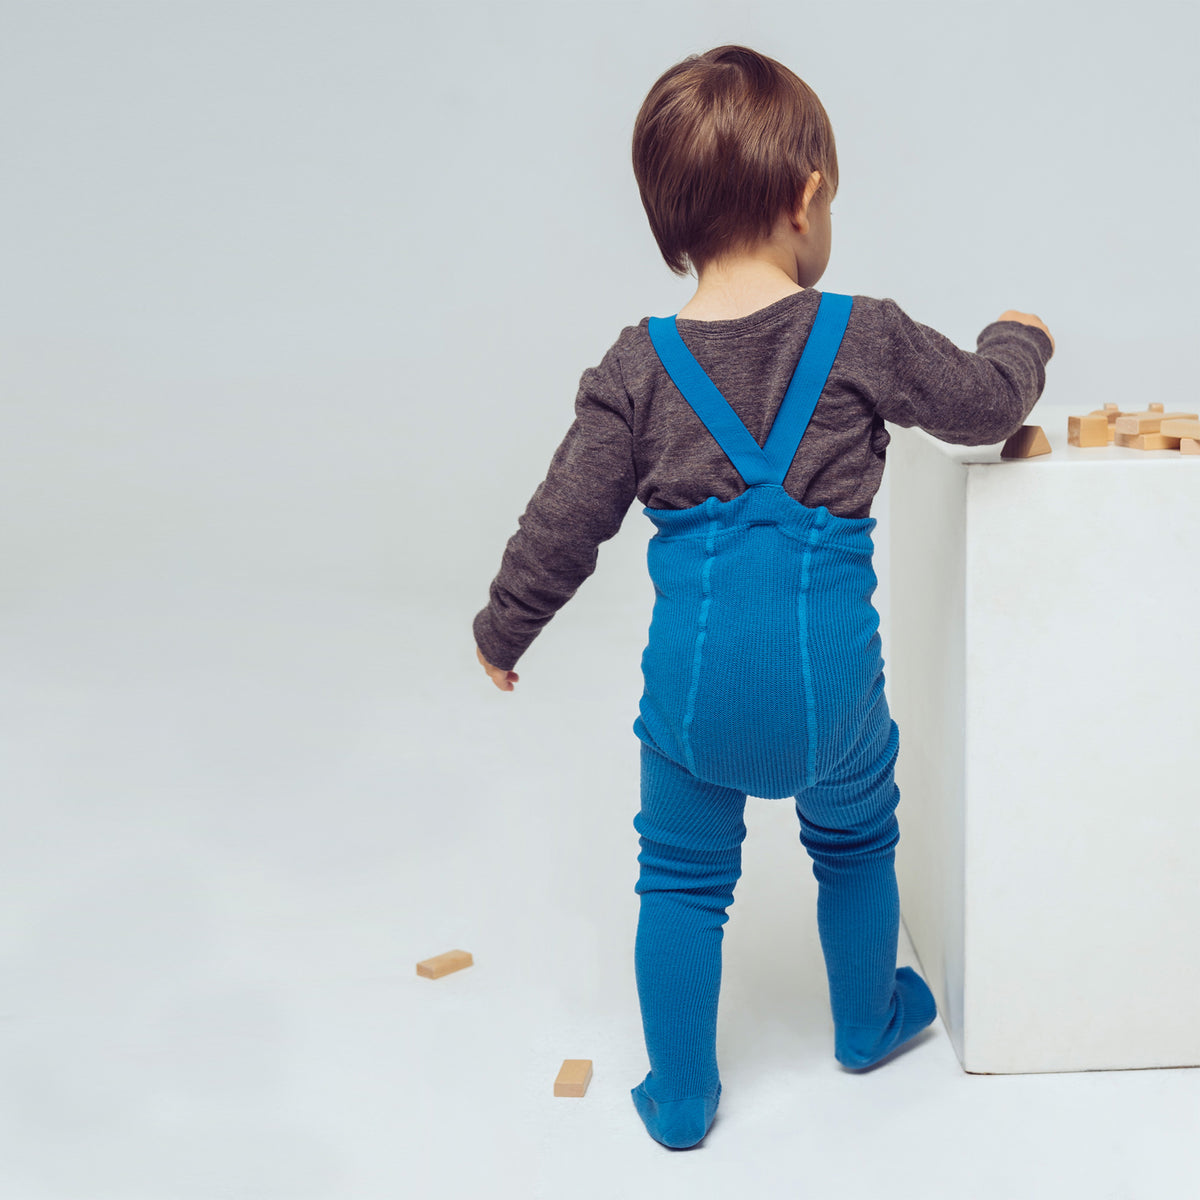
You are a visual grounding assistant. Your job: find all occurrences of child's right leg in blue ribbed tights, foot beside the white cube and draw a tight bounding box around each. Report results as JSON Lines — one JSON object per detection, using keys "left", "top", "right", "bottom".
{"left": 796, "top": 700, "right": 937, "bottom": 1069}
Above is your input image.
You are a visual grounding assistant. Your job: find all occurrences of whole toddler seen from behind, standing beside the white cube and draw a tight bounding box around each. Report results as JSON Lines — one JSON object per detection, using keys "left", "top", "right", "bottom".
{"left": 474, "top": 46, "right": 1054, "bottom": 1148}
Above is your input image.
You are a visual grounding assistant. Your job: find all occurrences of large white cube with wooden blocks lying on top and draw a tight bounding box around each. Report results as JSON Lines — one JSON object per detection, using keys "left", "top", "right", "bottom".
{"left": 884, "top": 402, "right": 1200, "bottom": 1074}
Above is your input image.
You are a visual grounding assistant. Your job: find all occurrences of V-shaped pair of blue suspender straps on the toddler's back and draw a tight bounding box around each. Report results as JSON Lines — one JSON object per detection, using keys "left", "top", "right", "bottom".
{"left": 648, "top": 292, "right": 853, "bottom": 487}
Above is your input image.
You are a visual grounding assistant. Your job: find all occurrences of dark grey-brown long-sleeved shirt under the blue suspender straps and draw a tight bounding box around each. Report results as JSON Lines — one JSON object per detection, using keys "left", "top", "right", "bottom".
{"left": 474, "top": 288, "right": 1052, "bottom": 670}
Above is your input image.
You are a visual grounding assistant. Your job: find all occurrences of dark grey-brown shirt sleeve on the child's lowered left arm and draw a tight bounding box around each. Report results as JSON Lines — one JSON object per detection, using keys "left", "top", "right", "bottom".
{"left": 473, "top": 346, "right": 637, "bottom": 671}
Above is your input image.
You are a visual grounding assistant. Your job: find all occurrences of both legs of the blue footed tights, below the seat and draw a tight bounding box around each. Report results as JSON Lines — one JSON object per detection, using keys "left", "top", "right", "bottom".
{"left": 632, "top": 721, "right": 937, "bottom": 1148}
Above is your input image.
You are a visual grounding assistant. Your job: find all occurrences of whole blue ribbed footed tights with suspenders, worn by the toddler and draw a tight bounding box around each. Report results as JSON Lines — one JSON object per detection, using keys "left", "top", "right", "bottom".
{"left": 632, "top": 292, "right": 936, "bottom": 1148}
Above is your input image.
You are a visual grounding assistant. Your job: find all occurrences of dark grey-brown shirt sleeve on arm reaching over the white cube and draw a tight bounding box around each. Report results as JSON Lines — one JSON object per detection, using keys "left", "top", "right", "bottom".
{"left": 874, "top": 300, "right": 1054, "bottom": 445}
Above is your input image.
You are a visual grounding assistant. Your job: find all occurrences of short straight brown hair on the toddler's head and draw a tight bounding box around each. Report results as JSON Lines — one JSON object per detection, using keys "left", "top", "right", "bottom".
{"left": 634, "top": 46, "right": 838, "bottom": 275}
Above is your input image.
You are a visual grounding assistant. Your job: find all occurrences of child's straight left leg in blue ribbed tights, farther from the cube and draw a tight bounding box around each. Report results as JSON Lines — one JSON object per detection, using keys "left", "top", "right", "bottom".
{"left": 632, "top": 742, "right": 746, "bottom": 1148}
